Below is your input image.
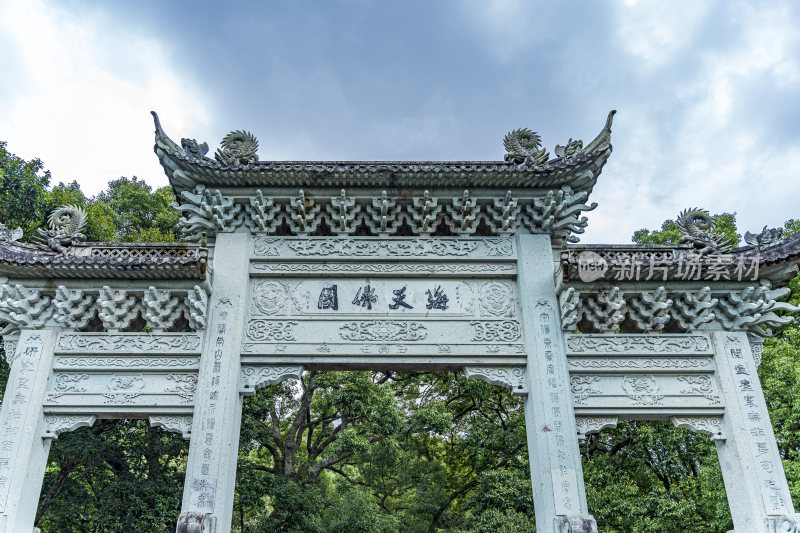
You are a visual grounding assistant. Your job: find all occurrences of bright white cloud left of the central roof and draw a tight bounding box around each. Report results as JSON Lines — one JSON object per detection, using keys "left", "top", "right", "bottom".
{"left": 0, "top": 0, "right": 208, "bottom": 194}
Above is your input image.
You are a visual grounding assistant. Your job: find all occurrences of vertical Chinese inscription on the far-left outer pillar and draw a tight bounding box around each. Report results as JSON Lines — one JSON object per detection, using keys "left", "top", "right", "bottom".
{"left": 0, "top": 333, "right": 43, "bottom": 512}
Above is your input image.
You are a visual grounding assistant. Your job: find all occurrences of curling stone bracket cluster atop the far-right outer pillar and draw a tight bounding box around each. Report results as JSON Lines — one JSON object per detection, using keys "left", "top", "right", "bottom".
{"left": 716, "top": 285, "right": 800, "bottom": 337}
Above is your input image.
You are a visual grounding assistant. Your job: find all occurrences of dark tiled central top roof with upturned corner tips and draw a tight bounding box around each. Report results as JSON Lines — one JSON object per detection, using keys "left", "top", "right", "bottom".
{"left": 153, "top": 112, "right": 614, "bottom": 195}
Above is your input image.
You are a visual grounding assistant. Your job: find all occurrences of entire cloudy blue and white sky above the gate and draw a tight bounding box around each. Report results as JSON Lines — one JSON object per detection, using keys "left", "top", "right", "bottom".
{"left": 0, "top": 0, "right": 800, "bottom": 243}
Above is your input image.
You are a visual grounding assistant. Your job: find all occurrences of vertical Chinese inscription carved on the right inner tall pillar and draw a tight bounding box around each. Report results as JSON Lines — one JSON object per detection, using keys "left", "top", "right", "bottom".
{"left": 533, "top": 298, "right": 580, "bottom": 515}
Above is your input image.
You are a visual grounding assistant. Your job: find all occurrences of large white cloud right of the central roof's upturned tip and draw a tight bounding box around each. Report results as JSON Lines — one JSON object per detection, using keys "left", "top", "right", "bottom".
{"left": 585, "top": 3, "right": 800, "bottom": 242}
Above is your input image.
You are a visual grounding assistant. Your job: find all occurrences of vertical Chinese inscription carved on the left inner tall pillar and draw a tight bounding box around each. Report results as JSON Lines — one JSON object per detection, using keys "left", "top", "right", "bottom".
{"left": 191, "top": 298, "right": 233, "bottom": 511}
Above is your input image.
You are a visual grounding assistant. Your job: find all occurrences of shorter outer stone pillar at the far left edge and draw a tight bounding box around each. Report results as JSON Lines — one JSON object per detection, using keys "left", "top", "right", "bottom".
{"left": 0, "top": 329, "right": 56, "bottom": 533}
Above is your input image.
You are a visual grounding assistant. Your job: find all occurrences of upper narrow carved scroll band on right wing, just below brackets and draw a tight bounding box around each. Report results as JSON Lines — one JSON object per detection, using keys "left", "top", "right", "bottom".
{"left": 567, "top": 334, "right": 711, "bottom": 355}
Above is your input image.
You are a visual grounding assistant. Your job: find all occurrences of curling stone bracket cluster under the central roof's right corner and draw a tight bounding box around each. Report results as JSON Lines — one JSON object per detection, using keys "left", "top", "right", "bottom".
{"left": 522, "top": 190, "right": 597, "bottom": 243}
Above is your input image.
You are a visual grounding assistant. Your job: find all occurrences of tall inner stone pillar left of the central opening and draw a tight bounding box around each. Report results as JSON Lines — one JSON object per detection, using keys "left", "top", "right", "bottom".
{"left": 176, "top": 233, "right": 250, "bottom": 533}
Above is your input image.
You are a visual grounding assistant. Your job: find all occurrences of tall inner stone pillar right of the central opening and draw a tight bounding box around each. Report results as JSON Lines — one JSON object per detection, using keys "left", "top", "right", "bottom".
{"left": 517, "top": 235, "right": 597, "bottom": 533}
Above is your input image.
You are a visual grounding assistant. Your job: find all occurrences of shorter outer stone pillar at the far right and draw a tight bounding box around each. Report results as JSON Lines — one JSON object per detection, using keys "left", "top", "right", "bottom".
{"left": 711, "top": 331, "right": 794, "bottom": 533}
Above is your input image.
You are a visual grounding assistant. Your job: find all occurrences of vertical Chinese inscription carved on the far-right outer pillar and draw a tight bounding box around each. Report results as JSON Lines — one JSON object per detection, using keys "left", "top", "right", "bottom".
{"left": 726, "top": 336, "right": 791, "bottom": 514}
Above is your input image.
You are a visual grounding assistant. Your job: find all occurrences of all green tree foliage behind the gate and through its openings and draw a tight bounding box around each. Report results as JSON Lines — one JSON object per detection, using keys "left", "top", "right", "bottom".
{"left": 0, "top": 143, "right": 800, "bottom": 533}
